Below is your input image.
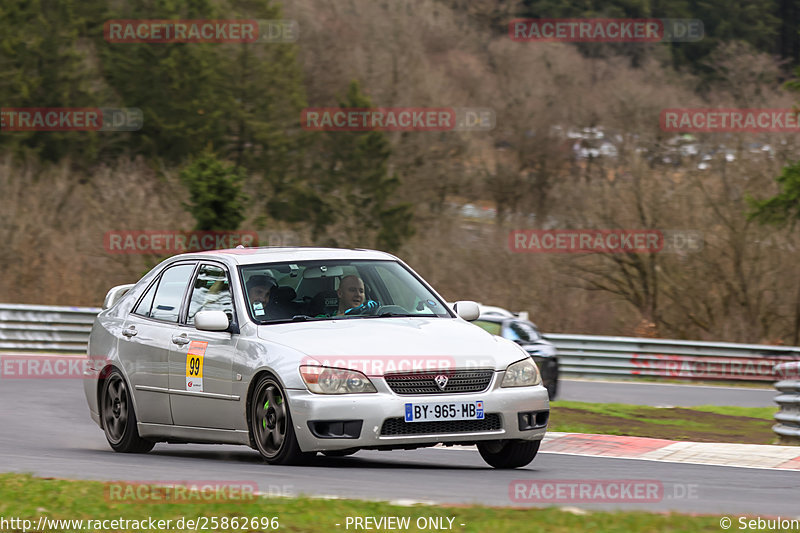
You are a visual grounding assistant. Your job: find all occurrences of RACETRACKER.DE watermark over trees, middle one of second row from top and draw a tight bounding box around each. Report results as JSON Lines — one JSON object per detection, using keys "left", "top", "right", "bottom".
{"left": 300, "top": 107, "right": 495, "bottom": 131}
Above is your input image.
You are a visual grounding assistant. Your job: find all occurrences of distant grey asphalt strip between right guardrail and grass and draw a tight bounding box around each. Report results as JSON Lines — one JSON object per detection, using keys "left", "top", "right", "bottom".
{"left": 556, "top": 378, "right": 778, "bottom": 407}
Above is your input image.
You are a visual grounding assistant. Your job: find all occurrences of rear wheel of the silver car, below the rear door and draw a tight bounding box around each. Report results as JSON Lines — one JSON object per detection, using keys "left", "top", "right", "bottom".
{"left": 100, "top": 369, "right": 155, "bottom": 453}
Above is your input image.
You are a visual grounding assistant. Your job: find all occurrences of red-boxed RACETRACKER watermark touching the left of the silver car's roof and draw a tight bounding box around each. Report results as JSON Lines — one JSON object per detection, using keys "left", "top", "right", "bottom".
{"left": 103, "top": 231, "right": 258, "bottom": 254}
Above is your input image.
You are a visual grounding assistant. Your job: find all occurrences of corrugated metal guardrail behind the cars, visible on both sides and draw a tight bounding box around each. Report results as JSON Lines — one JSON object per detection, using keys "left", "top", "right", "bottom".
{"left": 0, "top": 304, "right": 800, "bottom": 382}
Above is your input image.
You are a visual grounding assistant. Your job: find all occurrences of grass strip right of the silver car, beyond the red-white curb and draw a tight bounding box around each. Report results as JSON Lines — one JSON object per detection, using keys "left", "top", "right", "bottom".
{"left": 548, "top": 401, "right": 778, "bottom": 444}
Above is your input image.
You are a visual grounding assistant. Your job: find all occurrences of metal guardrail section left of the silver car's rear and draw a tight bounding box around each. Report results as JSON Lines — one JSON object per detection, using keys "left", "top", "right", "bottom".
{"left": 0, "top": 304, "right": 100, "bottom": 353}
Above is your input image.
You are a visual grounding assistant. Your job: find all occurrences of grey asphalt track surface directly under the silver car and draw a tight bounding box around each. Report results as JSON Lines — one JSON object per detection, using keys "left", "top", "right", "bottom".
{"left": 0, "top": 379, "right": 800, "bottom": 516}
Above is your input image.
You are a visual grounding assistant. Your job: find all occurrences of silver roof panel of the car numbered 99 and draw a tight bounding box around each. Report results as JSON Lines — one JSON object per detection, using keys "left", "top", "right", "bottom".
{"left": 172, "top": 246, "right": 397, "bottom": 265}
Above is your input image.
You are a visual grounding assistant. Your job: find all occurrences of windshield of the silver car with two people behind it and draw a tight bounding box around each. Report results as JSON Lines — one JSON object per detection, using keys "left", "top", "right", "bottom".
{"left": 240, "top": 260, "right": 453, "bottom": 324}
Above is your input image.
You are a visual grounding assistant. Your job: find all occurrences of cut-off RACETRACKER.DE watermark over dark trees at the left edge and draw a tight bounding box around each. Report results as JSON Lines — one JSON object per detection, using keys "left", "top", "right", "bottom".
{"left": 0, "top": 107, "right": 144, "bottom": 132}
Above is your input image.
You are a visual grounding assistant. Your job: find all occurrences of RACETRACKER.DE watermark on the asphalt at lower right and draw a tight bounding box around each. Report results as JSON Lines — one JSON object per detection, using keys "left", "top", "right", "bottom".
{"left": 508, "top": 479, "right": 698, "bottom": 503}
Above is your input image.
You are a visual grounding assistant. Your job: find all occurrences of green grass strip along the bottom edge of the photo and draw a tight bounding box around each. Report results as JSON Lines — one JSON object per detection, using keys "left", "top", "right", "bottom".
{"left": 0, "top": 474, "right": 720, "bottom": 533}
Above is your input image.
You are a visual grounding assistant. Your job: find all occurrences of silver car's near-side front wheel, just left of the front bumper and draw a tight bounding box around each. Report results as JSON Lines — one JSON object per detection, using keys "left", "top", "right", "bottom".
{"left": 250, "top": 375, "right": 316, "bottom": 465}
